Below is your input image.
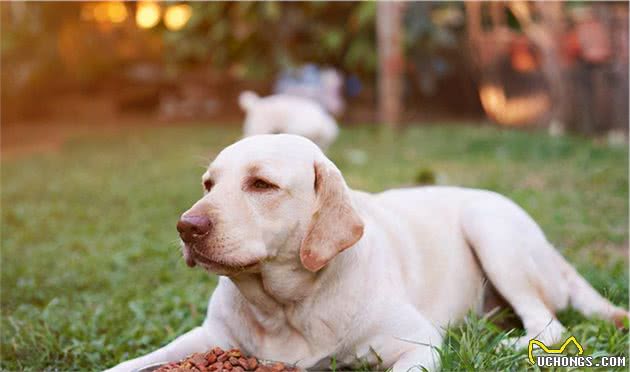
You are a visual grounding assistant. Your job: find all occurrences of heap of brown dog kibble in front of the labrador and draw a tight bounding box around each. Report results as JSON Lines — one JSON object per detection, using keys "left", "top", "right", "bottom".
{"left": 155, "top": 347, "right": 298, "bottom": 372}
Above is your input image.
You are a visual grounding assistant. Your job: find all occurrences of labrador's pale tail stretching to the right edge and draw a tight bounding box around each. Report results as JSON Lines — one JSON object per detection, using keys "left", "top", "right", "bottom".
{"left": 554, "top": 250, "right": 630, "bottom": 328}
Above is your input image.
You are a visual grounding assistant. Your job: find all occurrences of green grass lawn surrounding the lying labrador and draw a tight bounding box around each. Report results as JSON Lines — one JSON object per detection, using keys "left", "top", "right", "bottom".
{"left": 0, "top": 125, "right": 629, "bottom": 371}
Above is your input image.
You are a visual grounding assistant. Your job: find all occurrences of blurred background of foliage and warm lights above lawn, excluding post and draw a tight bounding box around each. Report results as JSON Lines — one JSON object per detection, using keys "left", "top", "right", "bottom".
{"left": 0, "top": 1, "right": 629, "bottom": 137}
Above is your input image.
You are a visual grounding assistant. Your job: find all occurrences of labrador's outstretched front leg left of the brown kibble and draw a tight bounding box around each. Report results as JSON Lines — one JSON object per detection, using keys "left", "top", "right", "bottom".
{"left": 106, "top": 320, "right": 232, "bottom": 372}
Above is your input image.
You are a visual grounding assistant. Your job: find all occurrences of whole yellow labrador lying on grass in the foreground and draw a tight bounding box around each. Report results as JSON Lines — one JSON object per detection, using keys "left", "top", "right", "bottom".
{"left": 114, "top": 134, "right": 627, "bottom": 371}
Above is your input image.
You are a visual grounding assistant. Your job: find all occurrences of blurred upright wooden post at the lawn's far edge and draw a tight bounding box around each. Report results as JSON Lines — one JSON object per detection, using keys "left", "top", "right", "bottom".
{"left": 376, "top": 1, "right": 404, "bottom": 128}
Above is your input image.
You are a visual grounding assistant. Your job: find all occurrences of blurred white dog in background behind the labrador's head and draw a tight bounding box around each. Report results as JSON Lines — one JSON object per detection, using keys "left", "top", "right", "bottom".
{"left": 239, "top": 91, "right": 339, "bottom": 150}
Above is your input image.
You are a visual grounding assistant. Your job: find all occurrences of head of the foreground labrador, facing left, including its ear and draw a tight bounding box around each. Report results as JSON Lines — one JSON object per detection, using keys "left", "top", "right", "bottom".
{"left": 177, "top": 134, "right": 363, "bottom": 275}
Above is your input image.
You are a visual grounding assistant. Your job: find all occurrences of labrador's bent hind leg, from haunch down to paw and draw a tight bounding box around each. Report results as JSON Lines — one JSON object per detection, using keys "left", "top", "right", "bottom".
{"left": 461, "top": 192, "right": 596, "bottom": 347}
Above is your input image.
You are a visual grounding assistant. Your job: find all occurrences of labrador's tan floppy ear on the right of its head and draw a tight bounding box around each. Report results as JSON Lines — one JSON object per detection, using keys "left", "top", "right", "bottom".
{"left": 300, "top": 162, "right": 363, "bottom": 272}
